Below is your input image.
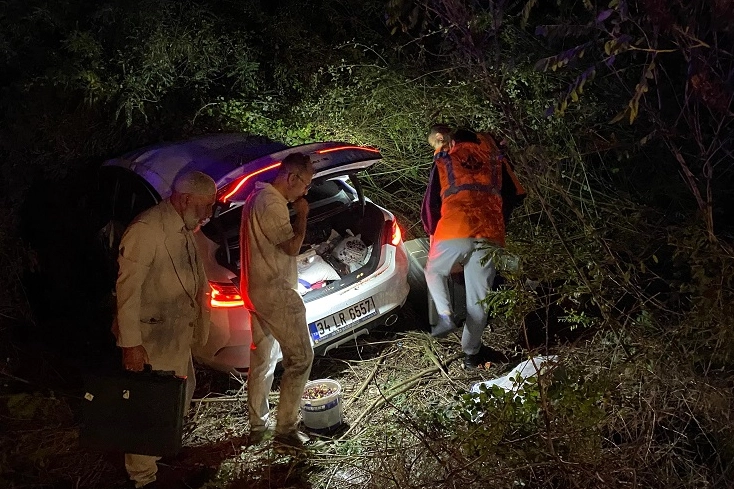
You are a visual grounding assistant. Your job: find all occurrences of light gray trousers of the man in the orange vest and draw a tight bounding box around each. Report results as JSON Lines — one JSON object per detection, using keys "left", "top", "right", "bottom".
{"left": 426, "top": 238, "right": 495, "bottom": 355}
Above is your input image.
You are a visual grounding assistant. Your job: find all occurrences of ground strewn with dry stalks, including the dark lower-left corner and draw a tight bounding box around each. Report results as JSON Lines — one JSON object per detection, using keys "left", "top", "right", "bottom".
{"left": 0, "top": 307, "right": 519, "bottom": 489}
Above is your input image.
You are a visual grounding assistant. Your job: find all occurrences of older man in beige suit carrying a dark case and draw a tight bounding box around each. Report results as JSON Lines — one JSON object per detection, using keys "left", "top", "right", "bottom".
{"left": 114, "top": 172, "right": 216, "bottom": 488}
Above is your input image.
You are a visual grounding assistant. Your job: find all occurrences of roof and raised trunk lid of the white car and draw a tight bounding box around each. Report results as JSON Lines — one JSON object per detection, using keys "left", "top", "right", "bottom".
{"left": 103, "top": 133, "right": 382, "bottom": 198}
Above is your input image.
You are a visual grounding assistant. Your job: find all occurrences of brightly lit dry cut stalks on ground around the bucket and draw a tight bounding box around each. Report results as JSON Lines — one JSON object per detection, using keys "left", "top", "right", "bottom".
{"left": 180, "top": 324, "right": 512, "bottom": 487}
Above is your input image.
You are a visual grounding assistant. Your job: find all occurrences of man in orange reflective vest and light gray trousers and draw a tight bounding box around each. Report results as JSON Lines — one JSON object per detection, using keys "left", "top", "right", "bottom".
{"left": 421, "top": 125, "right": 525, "bottom": 368}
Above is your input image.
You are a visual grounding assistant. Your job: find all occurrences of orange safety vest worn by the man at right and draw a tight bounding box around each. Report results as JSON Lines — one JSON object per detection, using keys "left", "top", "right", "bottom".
{"left": 434, "top": 134, "right": 505, "bottom": 246}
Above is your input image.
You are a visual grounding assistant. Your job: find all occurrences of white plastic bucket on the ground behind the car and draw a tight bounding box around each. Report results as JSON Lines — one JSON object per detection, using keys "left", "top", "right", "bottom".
{"left": 301, "top": 379, "right": 344, "bottom": 433}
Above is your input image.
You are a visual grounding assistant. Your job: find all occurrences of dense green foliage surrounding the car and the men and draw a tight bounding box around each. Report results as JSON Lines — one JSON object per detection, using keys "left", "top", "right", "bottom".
{"left": 0, "top": 0, "right": 734, "bottom": 488}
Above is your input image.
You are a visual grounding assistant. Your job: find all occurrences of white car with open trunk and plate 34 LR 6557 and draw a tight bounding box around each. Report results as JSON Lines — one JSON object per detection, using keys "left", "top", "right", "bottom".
{"left": 100, "top": 134, "right": 409, "bottom": 374}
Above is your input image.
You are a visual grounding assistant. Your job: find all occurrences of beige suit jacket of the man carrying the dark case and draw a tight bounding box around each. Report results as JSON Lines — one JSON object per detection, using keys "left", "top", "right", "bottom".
{"left": 113, "top": 200, "right": 209, "bottom": 368}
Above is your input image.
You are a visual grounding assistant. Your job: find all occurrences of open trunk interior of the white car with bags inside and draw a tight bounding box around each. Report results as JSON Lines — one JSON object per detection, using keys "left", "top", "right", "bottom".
{"left": 203, "top": 180, "right": 389, "bottom": 302}
